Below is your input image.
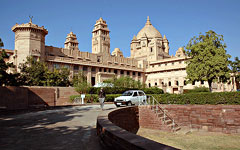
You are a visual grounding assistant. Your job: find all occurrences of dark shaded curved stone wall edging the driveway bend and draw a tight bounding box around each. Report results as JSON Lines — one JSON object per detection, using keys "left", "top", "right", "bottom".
{"left": 97, "top": 107, "right": 176, "bottom": 150}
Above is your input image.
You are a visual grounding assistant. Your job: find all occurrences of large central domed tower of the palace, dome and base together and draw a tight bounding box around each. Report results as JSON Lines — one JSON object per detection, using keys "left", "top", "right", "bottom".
{"left": 131, "top": 17, "right": 170, "bottom": 61}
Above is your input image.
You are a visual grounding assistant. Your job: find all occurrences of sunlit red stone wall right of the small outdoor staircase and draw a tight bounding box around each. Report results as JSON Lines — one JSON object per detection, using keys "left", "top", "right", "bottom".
{"left": 162, "top": 105, "right": 240, "bottom": 133}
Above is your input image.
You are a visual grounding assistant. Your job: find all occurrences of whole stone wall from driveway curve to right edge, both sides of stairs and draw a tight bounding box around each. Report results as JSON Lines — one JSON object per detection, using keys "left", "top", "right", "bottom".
{"left": 97, "top": 105, "right": 240, "bottom": 150}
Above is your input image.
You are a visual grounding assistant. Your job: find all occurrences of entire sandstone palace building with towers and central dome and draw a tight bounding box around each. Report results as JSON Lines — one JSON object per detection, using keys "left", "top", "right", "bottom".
{"left": 1, "top": 17, "right": 236, "bottom": 93}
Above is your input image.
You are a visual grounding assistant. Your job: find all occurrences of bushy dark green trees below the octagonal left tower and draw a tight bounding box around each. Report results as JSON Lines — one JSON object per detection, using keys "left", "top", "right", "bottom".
{"left": 20, "top": 57, "right": 70, "bottom": 86}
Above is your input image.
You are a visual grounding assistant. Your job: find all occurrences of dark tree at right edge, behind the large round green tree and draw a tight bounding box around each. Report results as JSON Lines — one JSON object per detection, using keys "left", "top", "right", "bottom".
{"left": 230, "top": 57, "right": 240, "bottom": 88}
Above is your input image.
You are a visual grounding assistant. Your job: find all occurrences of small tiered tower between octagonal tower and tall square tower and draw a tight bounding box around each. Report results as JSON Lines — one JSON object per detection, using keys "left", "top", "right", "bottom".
{"left": 64, "top": 32, "right": 78, "bottom": 49}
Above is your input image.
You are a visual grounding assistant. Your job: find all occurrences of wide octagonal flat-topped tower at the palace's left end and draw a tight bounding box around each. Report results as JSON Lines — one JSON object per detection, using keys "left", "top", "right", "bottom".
{"left": 12, "top": 17, "right": 48, "bottom": 66}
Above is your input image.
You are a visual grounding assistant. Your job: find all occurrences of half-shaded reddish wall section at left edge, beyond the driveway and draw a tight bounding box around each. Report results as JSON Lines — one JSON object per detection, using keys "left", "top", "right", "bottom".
{"left": 0, "top": 86, "right": 56, "bottom": 110}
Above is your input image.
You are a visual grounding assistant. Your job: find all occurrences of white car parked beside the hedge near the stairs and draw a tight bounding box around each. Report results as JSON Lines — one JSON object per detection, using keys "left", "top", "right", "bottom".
{"left": 114, "top": 90, "right": 147, "bottom": 107}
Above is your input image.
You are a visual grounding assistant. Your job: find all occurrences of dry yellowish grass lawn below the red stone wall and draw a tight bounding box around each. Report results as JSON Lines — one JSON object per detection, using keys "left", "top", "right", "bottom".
{"left": 137, "top": 128, "right": 240, "bottom": 150}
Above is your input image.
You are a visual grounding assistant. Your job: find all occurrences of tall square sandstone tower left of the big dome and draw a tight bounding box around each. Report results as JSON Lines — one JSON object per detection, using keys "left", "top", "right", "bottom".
{"left": 92, "top": 17, "right": 110, "bottom": 55}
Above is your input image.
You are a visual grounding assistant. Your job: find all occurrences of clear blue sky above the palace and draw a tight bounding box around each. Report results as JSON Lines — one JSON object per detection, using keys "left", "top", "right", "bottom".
{"left": 0, "top": 0, "right": 240, "bottom": 57}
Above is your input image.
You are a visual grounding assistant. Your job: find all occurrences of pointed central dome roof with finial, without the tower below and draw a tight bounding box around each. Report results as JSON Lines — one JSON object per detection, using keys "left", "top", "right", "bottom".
{"left": 137, "top": 17, "right": 162, "bottom": 39}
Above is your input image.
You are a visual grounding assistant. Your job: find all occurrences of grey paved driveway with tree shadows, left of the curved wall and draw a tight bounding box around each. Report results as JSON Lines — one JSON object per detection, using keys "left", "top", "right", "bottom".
{"left": 0, "top": 104, "right": 115, "bottom": 150}
